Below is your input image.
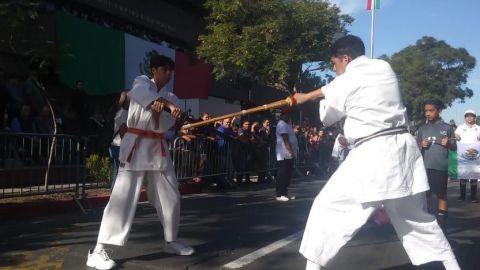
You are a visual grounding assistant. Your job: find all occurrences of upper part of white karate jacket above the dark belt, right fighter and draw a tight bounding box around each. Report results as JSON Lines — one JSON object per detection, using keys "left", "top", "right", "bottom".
{"left": 320, "top": 56, "right": 407, "bottom": 141}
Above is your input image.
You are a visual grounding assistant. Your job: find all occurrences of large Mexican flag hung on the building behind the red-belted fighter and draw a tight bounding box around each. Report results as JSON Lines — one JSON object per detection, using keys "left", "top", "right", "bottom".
{"left": 56, "top": 12, "right": 210, "bottom": 99}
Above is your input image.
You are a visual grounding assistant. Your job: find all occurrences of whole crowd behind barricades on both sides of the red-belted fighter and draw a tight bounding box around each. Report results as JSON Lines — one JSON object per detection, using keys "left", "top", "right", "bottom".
{"left": 0, "top": 64, "right": 338, "bottom": 185}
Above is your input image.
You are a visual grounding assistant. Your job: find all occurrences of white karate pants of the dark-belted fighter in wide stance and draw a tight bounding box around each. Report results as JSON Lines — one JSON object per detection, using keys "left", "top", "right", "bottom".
{"left": 300, "top": 182, "right": 455, "bottom": 266}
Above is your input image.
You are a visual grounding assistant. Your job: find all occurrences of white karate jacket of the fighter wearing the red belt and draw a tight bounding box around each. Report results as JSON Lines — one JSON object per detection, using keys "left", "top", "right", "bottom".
{"left": 119, "top": 75, "right": 179, "bottom": 171}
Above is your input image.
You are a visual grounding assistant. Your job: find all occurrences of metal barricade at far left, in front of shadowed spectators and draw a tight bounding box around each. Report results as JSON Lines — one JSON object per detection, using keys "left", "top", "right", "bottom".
{"left": 0, "top": 133, "right": 83, "bottom": 199}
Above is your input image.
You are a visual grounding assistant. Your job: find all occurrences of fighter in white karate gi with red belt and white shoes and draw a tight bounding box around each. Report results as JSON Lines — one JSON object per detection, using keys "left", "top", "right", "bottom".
{"left": 87, "top": 55, "right": 195, "bottom": 269}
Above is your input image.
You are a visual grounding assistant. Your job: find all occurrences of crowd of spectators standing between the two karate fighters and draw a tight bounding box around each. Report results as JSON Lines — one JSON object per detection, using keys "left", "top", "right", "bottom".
{"left": 181, "top": 112, "right": 340, "bottom": 190}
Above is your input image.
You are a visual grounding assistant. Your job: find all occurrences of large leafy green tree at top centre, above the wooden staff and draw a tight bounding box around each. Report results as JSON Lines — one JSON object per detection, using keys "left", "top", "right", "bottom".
{"left": 197, "top": 0, "right": 353, "bottom": 90}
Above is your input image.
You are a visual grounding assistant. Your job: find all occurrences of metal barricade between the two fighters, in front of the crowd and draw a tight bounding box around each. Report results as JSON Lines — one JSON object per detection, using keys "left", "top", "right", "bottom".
{"left": 170, "top": 136, "right": 308, "bottom": 184}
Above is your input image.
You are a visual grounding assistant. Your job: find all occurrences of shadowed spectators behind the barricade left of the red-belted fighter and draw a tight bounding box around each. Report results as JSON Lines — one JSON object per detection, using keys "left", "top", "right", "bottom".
{"left": 0, "top": 64, "right": 119, "bottom": 159}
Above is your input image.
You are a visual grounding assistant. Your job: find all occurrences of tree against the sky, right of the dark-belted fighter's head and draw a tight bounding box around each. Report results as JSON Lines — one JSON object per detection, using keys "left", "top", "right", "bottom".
{"left": 383, "top": 37, "right": 476, "bottom": 120}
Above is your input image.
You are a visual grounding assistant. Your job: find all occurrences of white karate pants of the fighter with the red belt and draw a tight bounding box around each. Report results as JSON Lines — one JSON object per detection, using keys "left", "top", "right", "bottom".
{"left": 98, "top": 170, "right": 181, "bottom": 246}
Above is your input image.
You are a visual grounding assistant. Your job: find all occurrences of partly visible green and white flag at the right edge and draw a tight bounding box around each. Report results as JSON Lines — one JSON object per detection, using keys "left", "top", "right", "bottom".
{"left": 448, "top": 142, "right": 480, "bottom": 179}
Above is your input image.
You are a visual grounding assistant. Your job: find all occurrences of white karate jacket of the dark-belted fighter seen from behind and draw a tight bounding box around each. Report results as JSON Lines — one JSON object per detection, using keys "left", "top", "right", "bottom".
{"left": 320, "top": 56, "right": 429, "bottom": 202}
